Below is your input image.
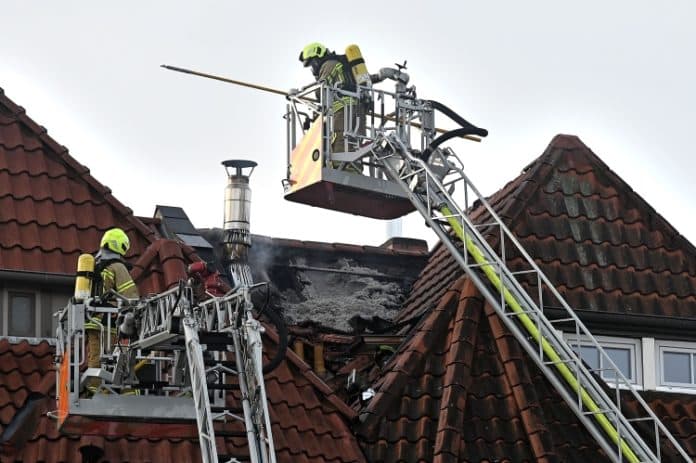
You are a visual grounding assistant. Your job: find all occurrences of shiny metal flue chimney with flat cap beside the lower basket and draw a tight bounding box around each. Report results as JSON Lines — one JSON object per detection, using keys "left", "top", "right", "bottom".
{"left": 222, "top": 159, "right": 256, "bottom": 286}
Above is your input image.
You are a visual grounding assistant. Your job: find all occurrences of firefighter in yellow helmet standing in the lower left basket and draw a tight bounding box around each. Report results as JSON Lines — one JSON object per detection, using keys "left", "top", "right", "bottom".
{"left": 85, "top": 228, "right": 140, "bottom": 393}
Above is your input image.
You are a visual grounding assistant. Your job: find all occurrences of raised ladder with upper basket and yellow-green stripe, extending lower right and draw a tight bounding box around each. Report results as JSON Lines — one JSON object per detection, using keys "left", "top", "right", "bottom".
{"left": 283, "top": 49, "right": 691, "bottom": 463}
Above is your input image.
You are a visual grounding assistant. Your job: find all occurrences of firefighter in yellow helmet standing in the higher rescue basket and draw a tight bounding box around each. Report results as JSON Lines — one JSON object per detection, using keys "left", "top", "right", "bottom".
{"left": 300, "top": 42, "right": 365, "bottom": 167}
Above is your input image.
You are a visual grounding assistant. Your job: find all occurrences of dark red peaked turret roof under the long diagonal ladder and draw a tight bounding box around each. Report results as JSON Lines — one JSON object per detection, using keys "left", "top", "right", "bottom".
{"left": 358, "top": 278, "right": 606, "bottom": 462}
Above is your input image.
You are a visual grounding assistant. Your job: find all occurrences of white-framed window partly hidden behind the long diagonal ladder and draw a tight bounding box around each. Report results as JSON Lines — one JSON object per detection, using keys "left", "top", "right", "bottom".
{"left": 565, "top": 334, "right": 642, "bottom": 384}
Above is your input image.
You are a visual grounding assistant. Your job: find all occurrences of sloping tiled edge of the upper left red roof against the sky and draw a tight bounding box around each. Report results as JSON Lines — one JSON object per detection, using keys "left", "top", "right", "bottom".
{"left": 0, "top": 87, "right": 153, "bottom": 246}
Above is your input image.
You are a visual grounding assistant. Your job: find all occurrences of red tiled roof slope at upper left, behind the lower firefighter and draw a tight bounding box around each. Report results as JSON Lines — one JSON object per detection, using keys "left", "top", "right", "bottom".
{"left": 0, "top": 89, "right": 154, "bottom": 274}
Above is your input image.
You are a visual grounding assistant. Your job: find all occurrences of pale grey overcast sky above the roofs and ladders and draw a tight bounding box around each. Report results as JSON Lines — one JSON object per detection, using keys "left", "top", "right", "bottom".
{"left": 0, "top": 0, "right": 696, "bottom": 250}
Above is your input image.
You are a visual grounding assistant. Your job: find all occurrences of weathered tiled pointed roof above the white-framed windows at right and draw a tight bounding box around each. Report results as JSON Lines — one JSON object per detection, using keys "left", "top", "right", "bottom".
{"left": 399, "top": 135, "right": 696, "bottom": 326}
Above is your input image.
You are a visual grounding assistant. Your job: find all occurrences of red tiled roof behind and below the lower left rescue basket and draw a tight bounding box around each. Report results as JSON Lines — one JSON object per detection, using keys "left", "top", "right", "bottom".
{"left": 0, "top": 240, "right": 364, "bottom": 463}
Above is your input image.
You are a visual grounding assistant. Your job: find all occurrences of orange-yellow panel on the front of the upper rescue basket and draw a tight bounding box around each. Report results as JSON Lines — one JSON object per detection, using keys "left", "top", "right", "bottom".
{"left": 290, "top": 116, "right": 324, "bottom": 191}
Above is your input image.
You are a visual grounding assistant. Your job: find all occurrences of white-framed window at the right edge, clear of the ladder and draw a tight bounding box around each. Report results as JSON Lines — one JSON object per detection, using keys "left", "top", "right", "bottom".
{"left": 656, "top": 341, "right": 696, "bottom": 389}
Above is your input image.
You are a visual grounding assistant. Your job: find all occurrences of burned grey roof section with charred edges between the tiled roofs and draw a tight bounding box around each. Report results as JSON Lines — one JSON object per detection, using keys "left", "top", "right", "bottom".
{"left": 196, "top": 229, "right": 428, "bottom": 332}
